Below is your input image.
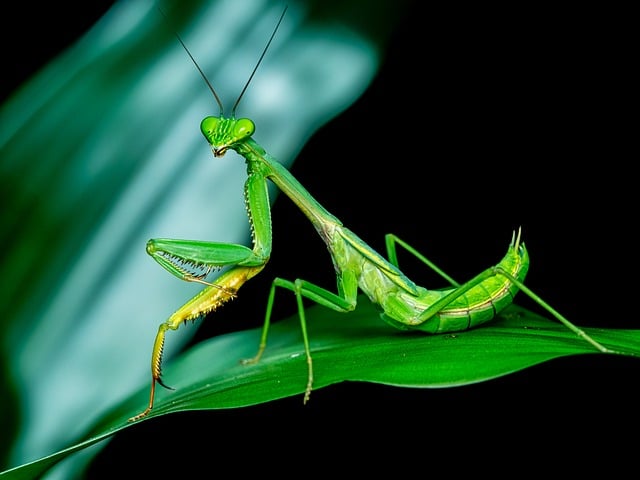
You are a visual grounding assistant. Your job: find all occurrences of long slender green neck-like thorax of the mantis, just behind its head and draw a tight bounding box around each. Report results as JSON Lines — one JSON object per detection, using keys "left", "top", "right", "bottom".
{"left": 236, "top": 138, "right": 342, "bottom": 238}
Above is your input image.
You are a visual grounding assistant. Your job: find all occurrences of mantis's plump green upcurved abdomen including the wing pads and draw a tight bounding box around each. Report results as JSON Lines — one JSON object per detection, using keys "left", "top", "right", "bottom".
{"left": 329, "top": 226, "right": 529, "bottom": 333}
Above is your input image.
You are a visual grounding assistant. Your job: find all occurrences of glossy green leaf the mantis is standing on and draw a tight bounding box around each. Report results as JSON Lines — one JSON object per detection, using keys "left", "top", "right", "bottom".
{"left": 0, "top": 296, "right": 640, "bottom": 479}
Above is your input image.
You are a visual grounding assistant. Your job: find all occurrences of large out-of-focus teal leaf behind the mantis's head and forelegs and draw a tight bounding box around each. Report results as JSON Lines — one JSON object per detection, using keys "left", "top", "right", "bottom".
{"left": 0, "top": 0, "right": 393, "bottom": 474}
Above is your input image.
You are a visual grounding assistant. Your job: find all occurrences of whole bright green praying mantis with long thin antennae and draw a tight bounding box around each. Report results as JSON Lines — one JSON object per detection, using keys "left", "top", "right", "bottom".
{"left": 129, "top": 9, "right": 616, "bottom": 421}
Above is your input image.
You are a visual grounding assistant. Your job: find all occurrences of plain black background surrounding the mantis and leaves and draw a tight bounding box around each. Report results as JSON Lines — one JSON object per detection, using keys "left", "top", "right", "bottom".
{"left": 2, "top": 2, "right": 639, "bottom": 478}
